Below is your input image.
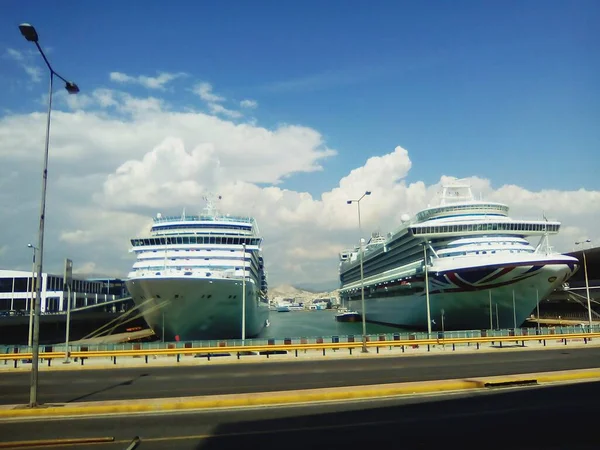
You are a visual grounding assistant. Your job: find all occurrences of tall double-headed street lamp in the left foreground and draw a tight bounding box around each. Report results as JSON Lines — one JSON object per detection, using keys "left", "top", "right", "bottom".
{"left": 19, "top": 23, "right": 79, "bottom": 408}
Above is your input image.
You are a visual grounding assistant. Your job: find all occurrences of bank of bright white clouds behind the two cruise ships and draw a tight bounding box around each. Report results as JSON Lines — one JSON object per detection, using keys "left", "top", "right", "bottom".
{"left": 0, "top": 77, "right": 600, "bottom": 285}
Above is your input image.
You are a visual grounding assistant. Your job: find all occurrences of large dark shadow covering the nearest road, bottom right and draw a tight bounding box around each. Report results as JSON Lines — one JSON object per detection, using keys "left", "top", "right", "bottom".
{"left": 195, "top": 382, "right": 600, "bottom": 450}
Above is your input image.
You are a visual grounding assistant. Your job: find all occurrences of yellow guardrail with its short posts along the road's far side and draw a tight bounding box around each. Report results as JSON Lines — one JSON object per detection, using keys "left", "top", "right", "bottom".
{"left": 0, "top": 332, "right": 600, "bottom": 368}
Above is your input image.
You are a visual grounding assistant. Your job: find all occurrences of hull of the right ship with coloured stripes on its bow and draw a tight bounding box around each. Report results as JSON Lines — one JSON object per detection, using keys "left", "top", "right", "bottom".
{"left": 350, "top": 261, "right": 576, "bottom": 330}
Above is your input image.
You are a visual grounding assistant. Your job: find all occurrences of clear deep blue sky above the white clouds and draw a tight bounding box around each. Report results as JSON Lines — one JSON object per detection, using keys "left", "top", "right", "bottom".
{"left": 0, "top": 0, "right": 600, "bottom": 286}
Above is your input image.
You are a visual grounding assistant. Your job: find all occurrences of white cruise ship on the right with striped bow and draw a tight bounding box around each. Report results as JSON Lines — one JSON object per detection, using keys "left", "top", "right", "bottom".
{"left": 339, "top": 181, "right": 579, "bottom": 330}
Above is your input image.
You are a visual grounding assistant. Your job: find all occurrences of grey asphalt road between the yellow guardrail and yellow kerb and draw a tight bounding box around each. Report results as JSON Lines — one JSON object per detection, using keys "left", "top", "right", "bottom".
{"left": 0, "top": 347, "right": 600, "bottom": 404}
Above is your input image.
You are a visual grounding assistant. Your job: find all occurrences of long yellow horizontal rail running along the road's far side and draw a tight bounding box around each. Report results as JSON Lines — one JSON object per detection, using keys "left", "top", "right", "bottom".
{"left": 0, "top": 333, "right": 600, "bottom": 361}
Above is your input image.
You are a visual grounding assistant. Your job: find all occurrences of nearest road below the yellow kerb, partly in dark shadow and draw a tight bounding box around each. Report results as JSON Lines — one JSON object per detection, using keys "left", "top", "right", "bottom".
{"left": 0, "top": 382, "right": 600, "bottom": 450}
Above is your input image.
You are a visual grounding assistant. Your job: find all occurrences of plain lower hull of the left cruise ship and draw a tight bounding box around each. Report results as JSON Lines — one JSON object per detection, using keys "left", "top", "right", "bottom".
{"left": 126, "top": 277, "right": 269, "bottom": 341}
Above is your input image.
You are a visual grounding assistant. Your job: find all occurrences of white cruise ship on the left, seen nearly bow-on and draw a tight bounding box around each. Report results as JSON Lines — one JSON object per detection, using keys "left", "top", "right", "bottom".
{"left": 126, "top": 197, "right": 269, "bottom": 341}
